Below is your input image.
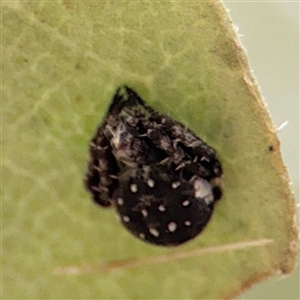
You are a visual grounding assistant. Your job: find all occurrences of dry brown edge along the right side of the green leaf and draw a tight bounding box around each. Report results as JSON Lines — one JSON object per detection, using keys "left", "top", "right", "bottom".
{"left": 213, "top": 1, "right": 298, "bottom": 299}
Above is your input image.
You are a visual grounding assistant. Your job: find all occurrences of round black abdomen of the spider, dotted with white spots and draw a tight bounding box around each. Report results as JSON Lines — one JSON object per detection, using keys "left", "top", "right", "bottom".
{"left": 114, "top": 169, "right": 213, "bottom": 246}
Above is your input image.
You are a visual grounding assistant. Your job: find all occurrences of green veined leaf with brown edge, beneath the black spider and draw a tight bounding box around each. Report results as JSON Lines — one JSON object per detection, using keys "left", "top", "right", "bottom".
{"left": 2, "top": 1, "right": 297, "bottom": 299}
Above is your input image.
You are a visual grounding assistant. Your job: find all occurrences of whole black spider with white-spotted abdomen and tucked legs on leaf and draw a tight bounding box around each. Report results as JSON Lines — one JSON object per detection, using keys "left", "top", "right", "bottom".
{"left": 86, "top": 87, "right": 222, "bottom": 246}
